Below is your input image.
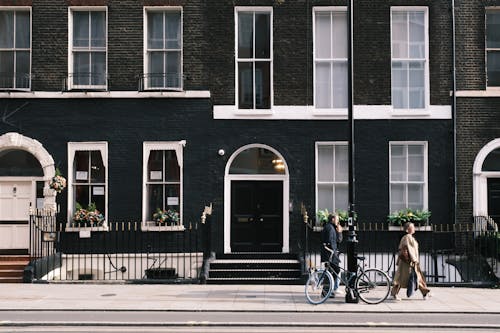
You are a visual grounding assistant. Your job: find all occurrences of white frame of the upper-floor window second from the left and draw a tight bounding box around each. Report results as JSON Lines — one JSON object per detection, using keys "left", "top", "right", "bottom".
{"left": 67, "top": 6, "right": 109, "bottom": 90}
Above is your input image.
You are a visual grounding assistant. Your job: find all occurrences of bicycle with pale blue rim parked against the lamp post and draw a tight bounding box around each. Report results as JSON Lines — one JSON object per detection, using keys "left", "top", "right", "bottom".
{"left": 305, "top": 246, "right": 391, "bottom": 304}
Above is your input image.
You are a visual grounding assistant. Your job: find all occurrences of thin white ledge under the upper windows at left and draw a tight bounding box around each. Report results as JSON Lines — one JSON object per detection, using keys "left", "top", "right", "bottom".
{"left": 0, "top": 90, "right": 210, "bottom": 98}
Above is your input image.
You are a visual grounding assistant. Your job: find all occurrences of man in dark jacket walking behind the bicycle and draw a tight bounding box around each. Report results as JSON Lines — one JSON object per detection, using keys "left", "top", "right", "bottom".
{"left": 321, "top": 214, "right": 342, "bottom": 297}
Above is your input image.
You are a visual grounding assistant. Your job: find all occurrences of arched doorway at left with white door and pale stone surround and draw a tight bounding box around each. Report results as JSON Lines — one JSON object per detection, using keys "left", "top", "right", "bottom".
{"left": 0, "top": 133, "right": 55, "bottom": 253}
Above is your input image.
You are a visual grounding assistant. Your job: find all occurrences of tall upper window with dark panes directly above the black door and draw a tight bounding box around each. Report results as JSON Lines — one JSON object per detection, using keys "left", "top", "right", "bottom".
{"left": 236, "top": 9, "right": 272, "bottom": 109}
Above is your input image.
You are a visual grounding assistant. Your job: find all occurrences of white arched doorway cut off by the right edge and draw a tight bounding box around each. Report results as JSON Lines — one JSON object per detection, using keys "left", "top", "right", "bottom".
{"left": 473, "top": 139, "right": 500, "bottom": 224}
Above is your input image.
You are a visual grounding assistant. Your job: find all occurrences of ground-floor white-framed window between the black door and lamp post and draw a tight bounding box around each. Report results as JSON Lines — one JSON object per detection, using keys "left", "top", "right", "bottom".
{"left": 316, "top": 142, "right": 349, "bottom": 212}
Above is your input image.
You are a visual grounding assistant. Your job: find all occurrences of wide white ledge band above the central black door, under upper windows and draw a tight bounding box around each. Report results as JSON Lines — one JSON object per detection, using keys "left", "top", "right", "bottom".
{"left": 213, "top": 105, "right": 452, "bottom": 120}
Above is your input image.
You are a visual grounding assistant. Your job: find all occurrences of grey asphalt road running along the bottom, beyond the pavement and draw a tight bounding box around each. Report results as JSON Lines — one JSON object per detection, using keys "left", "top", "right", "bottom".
{"left": 0, "top": 310, "right": 500, "bottom": 333}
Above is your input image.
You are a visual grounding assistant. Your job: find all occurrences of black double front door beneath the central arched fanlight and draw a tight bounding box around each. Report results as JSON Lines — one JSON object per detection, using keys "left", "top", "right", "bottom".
{"left": 231, "top": 180, "right": 283, "bottom": 252}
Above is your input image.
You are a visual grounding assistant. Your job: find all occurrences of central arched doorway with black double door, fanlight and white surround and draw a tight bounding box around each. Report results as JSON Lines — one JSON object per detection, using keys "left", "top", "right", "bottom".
{"left": 224, "top": 144, "right": 289, "bottom": 253}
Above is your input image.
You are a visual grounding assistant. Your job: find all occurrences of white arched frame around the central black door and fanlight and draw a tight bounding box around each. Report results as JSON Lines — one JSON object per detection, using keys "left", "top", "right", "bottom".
{"left": 224, "top": 143, "right": 290, "bottom": 253}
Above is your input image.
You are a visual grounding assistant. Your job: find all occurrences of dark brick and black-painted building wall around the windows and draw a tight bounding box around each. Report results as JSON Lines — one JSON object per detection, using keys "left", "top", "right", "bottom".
{"left": 0, "top": 0, "right": 458, "bottom": 252}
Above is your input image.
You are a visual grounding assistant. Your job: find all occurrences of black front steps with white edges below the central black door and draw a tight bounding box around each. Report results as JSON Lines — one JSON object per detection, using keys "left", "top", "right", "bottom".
{"left": 206, "top": 252, "right": 303, "bottom": 284}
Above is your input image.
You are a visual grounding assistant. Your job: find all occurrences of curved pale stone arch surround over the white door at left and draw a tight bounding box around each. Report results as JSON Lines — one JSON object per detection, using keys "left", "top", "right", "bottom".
{"left": 0, "top": 132, "right": 56, "bottom": 211}
